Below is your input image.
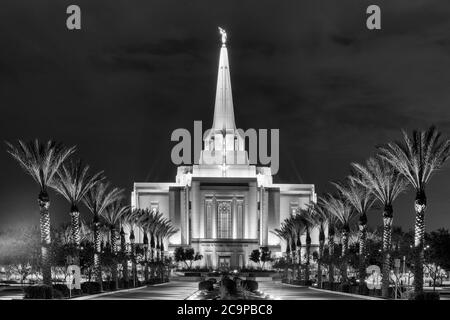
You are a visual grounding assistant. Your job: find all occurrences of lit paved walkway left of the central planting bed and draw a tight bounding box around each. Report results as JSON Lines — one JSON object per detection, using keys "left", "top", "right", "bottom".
{"left": 87, "top": 281, "right": 198, "bottom": 300}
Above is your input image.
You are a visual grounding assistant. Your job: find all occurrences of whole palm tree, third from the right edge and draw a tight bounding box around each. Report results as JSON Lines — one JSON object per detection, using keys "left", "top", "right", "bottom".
{"left": 332, "top": 179, "right": 375, "bottom": 290}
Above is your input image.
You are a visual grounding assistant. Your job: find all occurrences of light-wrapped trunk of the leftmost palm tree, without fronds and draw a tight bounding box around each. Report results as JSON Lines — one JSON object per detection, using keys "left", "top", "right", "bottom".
{"left": 38, "top": 191, "right": 52, "bottom": 286}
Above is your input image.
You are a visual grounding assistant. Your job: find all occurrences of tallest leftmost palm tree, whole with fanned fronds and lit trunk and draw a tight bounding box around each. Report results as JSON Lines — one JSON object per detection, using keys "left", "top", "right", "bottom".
{"left": 6, "top": 139, "right": 75, "bottom": 285}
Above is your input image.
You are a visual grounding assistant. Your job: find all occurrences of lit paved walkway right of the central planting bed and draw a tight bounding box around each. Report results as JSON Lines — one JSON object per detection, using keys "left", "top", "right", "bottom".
{"left": 258, "top": 281, "right": 364, "bottom": 300}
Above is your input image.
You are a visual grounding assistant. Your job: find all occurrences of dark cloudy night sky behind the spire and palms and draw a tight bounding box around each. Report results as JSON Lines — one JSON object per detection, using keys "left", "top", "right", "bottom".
{"left": 0, "top": 0, "right": 450, "bottom": 234}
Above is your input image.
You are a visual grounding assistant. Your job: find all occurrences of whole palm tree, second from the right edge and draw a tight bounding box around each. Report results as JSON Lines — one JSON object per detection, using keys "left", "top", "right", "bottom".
{"left": 352, "top": 157, "right": 407, "bottom": 298}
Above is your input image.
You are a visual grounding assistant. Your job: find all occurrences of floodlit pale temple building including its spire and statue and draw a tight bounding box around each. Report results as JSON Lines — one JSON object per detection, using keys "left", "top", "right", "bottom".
{"left": 126, "top": 29, "right": 318, "bottom": 269}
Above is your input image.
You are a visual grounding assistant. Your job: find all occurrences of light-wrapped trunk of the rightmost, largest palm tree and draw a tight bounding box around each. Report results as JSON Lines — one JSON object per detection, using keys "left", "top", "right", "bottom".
{"left": 414, "top": 190, "right": 427, "bottom": 295}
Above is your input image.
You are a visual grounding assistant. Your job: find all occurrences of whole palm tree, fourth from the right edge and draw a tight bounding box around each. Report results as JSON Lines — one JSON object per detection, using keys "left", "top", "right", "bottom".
{"left": 322, "top": 194, "right": 354, "bottom": 283}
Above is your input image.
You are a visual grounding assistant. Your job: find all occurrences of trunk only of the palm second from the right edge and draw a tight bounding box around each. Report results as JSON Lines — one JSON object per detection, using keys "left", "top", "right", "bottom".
{"left": 381, "top": 205, "right": 393, "bottom": 298}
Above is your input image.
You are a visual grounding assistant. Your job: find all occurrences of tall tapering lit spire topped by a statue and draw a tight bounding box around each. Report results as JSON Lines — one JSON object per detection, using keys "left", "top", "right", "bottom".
{"left": 212, "top": 27, "right": 236, "bottom": 130}
